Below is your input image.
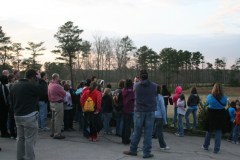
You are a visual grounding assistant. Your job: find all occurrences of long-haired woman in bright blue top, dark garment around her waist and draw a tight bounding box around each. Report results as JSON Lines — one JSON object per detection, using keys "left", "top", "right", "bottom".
{"left": 202, "top": 83, "right": 227, "bottom": 153}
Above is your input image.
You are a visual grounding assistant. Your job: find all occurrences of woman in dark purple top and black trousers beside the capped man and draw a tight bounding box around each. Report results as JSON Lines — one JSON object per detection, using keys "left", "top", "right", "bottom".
{"left": 122, "top": 79, "right": 135, "bottom": 144}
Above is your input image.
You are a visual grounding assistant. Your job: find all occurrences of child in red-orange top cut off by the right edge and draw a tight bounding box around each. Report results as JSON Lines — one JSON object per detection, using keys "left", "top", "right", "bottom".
{"left": 232, "top": 101, "right": 240, "bottom": 144}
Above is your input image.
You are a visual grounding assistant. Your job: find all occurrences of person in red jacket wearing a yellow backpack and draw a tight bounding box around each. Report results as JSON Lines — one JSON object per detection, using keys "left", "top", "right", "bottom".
{"left": 80, "top": 81, "right": 102, "bottom": 142}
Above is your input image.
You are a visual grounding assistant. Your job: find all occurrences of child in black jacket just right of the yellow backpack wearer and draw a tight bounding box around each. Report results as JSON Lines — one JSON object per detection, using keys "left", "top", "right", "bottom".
{"left": 102, "top": 88, "right": 113, "bottom": 134}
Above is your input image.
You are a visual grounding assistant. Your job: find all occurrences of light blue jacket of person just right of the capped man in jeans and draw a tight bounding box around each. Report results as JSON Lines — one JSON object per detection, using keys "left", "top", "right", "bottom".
{"left": 155, "top": 94, "right": 167, "bottom": 123}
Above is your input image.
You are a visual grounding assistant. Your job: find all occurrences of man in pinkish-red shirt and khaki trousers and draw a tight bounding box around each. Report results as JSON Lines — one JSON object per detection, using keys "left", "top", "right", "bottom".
{"left": 48, "top": 73, "right": 66, "bottom": 139}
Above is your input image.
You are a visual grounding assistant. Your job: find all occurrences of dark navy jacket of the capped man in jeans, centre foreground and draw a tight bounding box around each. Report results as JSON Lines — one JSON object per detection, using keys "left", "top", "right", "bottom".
{"left": 133, "top": 80, "right": 157, "bottom": 112}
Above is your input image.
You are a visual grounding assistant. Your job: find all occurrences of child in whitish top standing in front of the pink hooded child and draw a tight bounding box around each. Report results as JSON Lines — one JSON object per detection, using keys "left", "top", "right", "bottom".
{"left": 175, "top": 94, "right": 186, "bottom": 137}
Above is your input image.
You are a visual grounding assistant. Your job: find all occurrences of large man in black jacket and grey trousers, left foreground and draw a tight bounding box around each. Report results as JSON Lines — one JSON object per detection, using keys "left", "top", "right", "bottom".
{"left": 10, "top": 69, "right": 46, "bottom": 160}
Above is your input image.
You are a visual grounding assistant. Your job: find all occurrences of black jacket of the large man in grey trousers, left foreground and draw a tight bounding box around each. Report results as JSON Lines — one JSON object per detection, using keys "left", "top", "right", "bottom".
{"left": 10, "top": 79, "right": 46, "bottom": 116}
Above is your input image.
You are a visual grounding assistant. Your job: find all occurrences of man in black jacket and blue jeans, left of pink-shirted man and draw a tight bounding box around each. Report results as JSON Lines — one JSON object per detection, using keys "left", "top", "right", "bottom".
{"left": 38, "top": 72, "right": 50, "bottom": 131}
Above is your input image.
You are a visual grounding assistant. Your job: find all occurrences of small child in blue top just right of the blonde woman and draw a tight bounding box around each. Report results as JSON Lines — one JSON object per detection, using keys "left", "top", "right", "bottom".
{"left": 228, "top": 101, "right": 236, "bottom": 142}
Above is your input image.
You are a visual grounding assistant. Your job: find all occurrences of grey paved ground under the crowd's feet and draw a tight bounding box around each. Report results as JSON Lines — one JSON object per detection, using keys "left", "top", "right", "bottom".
{"left": 0, "top": 131, "right": 240, "bottom": 160}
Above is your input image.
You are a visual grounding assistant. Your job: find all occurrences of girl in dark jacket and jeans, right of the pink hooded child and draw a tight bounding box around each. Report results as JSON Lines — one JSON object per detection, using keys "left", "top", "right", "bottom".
{"left": 185, "top": 87, "right": 200, "bottom": 130}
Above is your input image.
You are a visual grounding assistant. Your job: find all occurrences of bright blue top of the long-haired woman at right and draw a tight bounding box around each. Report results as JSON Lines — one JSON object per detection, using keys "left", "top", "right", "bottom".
{"left": 206, "top": 94, "right": 227, "bottom": 109}
